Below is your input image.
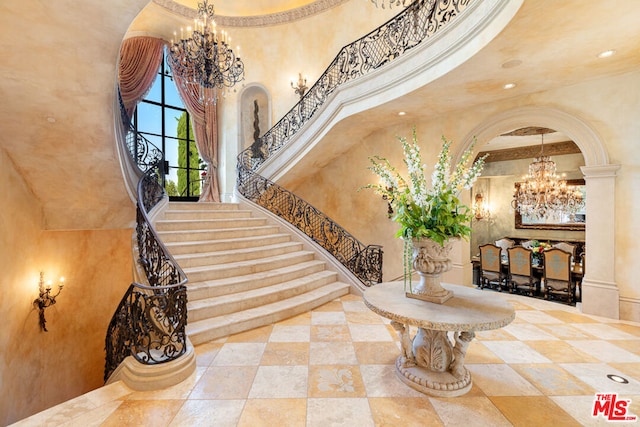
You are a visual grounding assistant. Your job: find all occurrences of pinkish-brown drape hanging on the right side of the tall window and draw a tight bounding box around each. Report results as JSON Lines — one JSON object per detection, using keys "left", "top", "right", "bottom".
{"left": 172, "top": 75, "right": 220, "bottom": 202}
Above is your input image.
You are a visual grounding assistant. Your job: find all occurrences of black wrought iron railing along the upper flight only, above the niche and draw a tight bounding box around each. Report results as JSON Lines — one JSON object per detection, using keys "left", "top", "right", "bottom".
{"left": 241, "top": 0, "right": 473, "bottom": 170}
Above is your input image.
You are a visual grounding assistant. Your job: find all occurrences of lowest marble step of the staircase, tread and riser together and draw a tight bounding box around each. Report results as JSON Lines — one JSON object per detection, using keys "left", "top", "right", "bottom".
{"left": 187, "top": 282, "right": 349, "bottom": 345}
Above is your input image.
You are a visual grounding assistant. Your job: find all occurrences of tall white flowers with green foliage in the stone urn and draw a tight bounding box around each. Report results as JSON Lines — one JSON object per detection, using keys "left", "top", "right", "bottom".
{"left": 365, "top": 127, "right": 486, "bottom": 246}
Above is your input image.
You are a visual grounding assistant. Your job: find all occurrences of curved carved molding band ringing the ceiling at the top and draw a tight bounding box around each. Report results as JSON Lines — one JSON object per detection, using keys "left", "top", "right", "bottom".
{"left": 153, "top": 0, "right": 349, "bottom": 27}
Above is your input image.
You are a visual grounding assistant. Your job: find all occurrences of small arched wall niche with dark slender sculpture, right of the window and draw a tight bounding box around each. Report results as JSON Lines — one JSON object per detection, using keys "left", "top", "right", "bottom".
{"left": 238, "top": 83, "right": 271, "bottom": 152}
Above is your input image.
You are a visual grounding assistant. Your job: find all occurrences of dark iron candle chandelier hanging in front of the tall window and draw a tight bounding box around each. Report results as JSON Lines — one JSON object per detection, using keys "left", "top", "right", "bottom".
{"left": 168, "top": 0, "right": 244, "bottom": 100}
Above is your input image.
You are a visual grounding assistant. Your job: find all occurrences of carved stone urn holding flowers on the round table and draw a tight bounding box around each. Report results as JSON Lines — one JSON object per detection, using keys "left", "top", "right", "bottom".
{"left": 406, "top": 238, "right": 459, "bottom": 304}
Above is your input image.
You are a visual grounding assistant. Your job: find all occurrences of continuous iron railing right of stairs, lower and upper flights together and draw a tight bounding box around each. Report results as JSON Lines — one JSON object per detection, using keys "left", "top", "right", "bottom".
{"left": 238, "top": 0, "right": 472, "bottom": 286}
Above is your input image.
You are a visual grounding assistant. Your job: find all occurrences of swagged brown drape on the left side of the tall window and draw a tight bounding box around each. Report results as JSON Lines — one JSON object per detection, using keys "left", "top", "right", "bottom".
{"left": 118, "top": 37, "right": 165, "bottom": 120}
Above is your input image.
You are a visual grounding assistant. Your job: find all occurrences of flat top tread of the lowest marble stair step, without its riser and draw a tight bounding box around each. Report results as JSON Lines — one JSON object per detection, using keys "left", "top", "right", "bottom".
{"left": 187, "top": 281, "right": 349, "bottom": 335}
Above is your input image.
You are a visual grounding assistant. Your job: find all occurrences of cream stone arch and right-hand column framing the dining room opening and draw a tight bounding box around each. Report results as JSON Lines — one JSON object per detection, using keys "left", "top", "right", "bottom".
{"left": 455, "top": 106, "right": 620, "bottom": 319}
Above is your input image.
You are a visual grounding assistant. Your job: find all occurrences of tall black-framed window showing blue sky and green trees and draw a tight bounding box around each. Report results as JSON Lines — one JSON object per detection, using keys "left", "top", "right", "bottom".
{"left": 133, "top": 51, "right": 205, "bottom": 201}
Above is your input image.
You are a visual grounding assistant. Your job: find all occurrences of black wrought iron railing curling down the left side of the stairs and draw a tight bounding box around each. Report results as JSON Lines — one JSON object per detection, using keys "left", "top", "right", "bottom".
{"left": 104, "top": 93, "right": 187, "bottom": 381}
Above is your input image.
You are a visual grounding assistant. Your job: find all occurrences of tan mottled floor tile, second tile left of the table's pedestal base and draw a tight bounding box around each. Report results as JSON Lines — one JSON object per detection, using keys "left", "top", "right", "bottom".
{"left": 308, "top": 365, "right": 366, "bottom": 398}
